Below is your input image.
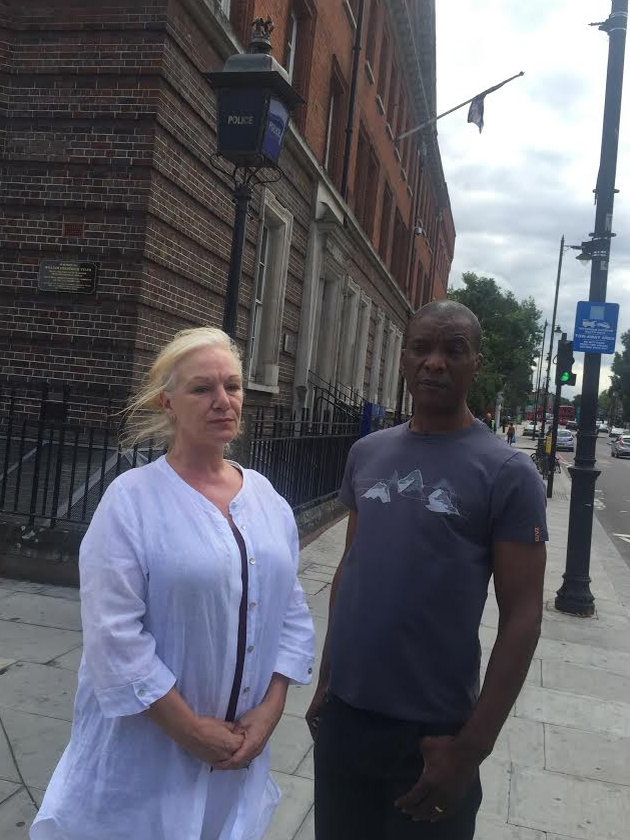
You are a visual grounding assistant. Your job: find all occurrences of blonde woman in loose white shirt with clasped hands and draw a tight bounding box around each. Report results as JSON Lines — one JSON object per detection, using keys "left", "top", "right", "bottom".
{"left": 31, "top": 328, "right": 313, "bottom": 840}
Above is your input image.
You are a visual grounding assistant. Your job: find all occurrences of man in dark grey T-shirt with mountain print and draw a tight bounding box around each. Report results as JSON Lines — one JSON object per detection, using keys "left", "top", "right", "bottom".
{"left": 307, "top": 301, "right": 547, "bottom": 840}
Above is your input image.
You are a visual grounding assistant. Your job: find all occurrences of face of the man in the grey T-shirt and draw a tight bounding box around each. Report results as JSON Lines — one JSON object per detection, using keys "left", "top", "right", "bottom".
{"left": 402, "top": 315, "right": 483, "bottom": 414}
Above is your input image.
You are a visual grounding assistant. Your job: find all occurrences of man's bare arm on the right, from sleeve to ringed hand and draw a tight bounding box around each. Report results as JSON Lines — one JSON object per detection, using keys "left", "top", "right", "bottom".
{"left": 396, "top": 542, "right": 546, "bottom": 821}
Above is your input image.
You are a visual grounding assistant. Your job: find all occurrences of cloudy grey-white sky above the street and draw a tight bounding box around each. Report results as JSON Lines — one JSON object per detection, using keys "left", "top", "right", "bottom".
{"left": 436, "top": 0, "right": 630, "bottom": 397}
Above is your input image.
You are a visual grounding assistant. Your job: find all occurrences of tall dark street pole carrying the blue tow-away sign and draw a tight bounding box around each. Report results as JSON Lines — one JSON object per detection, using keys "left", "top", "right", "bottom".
{"left": 556, "top": 0, "right": 628, "bottom": 616}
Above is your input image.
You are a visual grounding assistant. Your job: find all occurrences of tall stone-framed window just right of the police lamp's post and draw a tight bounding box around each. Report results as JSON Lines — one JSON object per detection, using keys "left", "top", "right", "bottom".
{"left": 247, "top": 193, "right": 293, "bottom": 390}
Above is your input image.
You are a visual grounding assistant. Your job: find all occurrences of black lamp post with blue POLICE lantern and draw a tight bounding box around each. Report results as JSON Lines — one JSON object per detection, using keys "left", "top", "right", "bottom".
{"left": 206, "top": 18, "right": 303, "bottom": 338}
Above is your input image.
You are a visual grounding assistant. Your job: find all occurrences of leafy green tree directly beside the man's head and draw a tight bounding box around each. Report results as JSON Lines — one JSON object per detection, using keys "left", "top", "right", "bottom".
{"left": 449, "top": 271, "right": 542, "bottom": 414}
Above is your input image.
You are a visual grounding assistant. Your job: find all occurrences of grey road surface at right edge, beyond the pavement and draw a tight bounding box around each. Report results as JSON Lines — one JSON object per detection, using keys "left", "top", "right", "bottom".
{"left": 592, "top": 435, "right": 630, "bottom": 566}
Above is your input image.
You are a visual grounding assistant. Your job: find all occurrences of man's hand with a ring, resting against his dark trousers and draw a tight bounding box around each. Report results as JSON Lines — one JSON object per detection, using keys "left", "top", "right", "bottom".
{"left": 394, "top": 736, "right": 480, "bottom": 822}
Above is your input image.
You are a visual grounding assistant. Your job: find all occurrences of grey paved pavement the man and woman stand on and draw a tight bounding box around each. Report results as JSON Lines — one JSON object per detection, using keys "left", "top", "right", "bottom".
{"left": 0, "top": 438, "right": 630, "bottom": 840}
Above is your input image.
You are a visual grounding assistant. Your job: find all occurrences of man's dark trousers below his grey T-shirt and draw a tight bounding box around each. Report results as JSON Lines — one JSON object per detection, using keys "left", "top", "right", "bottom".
{"left": 314, "top": 696, "right": 482, "bottom": 840}
